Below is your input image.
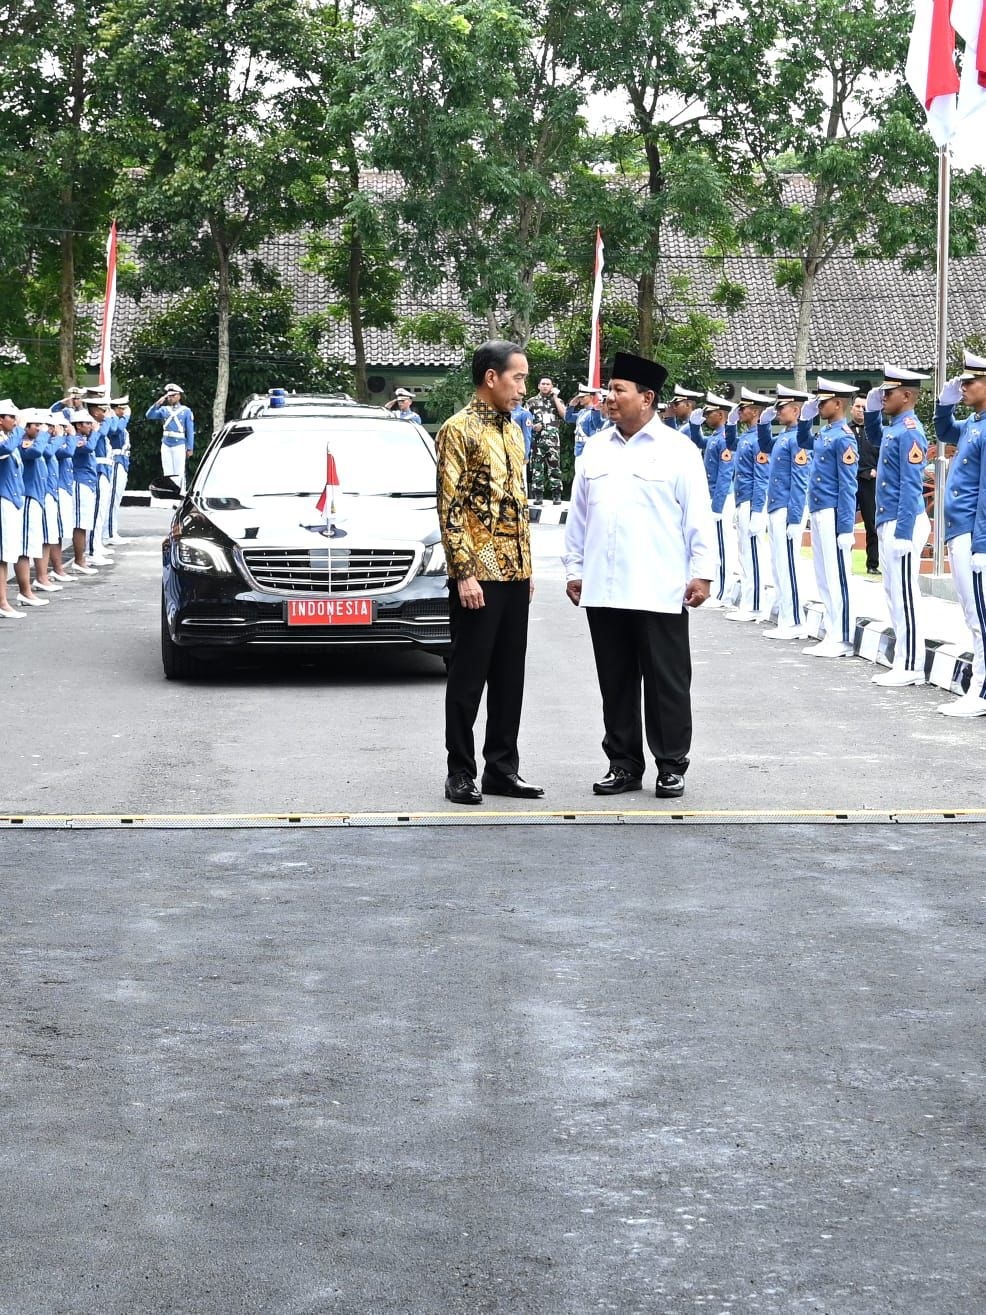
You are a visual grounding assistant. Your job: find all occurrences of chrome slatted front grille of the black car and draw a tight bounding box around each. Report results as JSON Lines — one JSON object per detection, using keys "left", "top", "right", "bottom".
{"left": 242, "top": 547, "right": 415, "bottom": 594}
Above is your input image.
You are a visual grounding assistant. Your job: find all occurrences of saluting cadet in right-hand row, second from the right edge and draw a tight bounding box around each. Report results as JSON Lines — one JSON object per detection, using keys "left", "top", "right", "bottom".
{"left": 864, "top": 366, "right": 931, "bottom": 686}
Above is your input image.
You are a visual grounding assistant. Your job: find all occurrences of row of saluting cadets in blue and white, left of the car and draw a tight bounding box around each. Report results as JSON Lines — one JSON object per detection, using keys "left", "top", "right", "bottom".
{"left": 0, "top": 389, "right": 130, "bottom": 619}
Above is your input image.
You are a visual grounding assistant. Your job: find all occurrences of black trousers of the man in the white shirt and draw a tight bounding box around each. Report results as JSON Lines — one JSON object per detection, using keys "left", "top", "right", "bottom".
{"left": 585, "top": 608, "right": 692, "bottom": 776}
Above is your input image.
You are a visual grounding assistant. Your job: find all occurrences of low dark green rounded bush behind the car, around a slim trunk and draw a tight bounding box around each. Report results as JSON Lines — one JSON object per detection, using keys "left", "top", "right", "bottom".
{"left": 113, "top": 288, "right": 351, "bottom": 488}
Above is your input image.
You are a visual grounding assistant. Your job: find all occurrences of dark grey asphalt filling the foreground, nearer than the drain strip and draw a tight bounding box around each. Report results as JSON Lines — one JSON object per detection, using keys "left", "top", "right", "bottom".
{"left": 0, "top": 826, "right": 986, "bottom": 1315}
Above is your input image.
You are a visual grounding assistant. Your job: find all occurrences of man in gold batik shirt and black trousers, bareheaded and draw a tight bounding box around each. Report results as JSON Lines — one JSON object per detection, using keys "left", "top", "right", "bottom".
{"left": 436, "top": 341, "right": 544, "bottom": 803}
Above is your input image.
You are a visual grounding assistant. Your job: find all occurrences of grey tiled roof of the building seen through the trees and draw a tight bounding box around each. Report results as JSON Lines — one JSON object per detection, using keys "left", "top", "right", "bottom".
{"left": 87, "top": 175, "right": 986, "bottom": 373}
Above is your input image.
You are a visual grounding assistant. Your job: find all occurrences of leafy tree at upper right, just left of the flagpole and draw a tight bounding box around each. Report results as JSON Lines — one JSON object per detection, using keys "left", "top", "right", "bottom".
{"left": 690, "top": 0, "right": 986, "bottom": 388}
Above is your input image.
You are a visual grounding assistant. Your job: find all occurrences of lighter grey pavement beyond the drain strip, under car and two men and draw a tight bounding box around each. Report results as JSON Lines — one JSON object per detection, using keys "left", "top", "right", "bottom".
{"left": 0, "top": 508, "right": 986, "bottom": 815}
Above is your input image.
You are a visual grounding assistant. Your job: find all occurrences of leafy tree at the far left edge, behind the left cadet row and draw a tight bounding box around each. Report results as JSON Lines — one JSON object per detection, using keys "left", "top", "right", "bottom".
{"left": 0, "top": 0, "right": 113, "bottom": 387}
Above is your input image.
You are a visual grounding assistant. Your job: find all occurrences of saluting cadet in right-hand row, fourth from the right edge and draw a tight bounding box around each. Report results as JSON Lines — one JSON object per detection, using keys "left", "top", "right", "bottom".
{"left": 757, "top": 384, "right": 811, "bottom": 639}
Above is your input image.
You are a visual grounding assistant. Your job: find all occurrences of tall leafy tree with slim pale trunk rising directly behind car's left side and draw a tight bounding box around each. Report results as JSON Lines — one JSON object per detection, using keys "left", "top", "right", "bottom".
{"left": 103, "top": 0, "right": 314, "bottom": 427}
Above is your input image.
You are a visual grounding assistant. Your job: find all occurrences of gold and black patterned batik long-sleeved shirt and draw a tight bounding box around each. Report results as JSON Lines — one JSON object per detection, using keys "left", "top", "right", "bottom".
{"left": 435, "top": 397, "right": 531, "bottom": 580}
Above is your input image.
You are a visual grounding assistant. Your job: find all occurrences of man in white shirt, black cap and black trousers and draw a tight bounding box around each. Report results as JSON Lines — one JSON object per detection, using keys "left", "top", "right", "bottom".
{"left": 564, "top": 352, "right": 716, "bottom": 798}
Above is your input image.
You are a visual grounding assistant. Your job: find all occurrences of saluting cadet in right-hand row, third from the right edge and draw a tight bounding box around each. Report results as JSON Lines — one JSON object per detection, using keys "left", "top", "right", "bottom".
{"left": 798, "top": 375, "right": 858, "bottom": 658}
